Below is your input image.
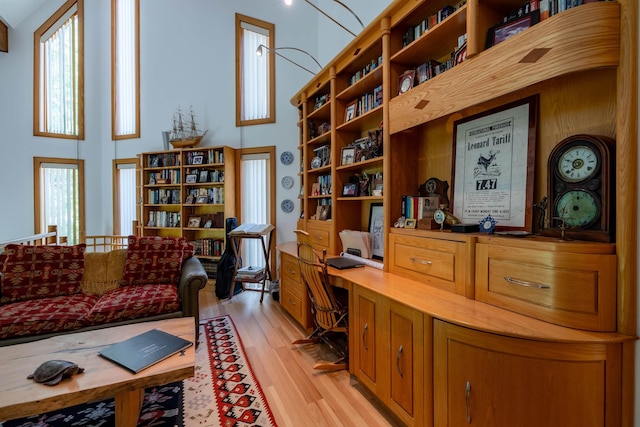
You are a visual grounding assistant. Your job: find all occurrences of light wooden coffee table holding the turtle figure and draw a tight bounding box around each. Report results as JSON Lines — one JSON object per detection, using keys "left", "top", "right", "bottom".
{"left": 0, "top": 317, "right": 195, "bottom": 427}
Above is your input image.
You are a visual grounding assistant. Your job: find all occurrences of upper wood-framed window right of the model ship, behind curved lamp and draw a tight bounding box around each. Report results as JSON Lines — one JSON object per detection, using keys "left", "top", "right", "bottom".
{"left": 236, "top": 14, "right": 276, "bottom": 126}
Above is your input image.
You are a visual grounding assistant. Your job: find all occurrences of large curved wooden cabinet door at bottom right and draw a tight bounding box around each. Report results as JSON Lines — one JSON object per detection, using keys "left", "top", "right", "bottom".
{"left": 434, "top": 321, "right": 620, "bottom": 427}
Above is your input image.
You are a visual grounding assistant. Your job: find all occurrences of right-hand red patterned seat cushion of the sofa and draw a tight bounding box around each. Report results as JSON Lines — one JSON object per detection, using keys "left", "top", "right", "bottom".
{"left": 87, "top": 284, "right": 180, "bottom": 325}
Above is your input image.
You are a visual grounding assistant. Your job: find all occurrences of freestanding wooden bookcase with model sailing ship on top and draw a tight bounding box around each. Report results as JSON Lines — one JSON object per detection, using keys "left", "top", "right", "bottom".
{"left": 138, "top": 146, "right": 236, "bottom": 260}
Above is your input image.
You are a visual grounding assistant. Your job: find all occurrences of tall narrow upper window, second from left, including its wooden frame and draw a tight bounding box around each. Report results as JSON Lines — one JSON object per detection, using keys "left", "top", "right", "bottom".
{"left": 111, "top": 0, "right": 140, "bottom": 140}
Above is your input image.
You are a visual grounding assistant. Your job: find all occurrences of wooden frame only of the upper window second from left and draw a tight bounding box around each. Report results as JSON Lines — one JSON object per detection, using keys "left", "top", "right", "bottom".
{"left": 111, "top": 0, "right": 140, "bottom": 141}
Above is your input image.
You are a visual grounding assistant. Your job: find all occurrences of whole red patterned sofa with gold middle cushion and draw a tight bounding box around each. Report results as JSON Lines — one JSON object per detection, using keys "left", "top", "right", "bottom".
{"left": 0, "top": 236, "right": 207, "bottom": 346}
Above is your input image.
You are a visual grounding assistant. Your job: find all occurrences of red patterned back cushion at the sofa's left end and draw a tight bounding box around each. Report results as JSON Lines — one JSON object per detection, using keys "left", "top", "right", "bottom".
{"left": 0, "top": 243, "right": 86, "bottom": 303}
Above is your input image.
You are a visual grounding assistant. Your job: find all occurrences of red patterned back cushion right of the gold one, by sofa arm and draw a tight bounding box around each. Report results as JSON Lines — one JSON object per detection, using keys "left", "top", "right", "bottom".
{"left": 120, "top": 236, "right": 186, "bottom": 286}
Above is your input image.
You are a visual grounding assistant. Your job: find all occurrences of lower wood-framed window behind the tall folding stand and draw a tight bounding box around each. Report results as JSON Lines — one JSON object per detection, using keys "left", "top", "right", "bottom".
{"left": 240, "top": 147, "right": 276, "bottom": 266}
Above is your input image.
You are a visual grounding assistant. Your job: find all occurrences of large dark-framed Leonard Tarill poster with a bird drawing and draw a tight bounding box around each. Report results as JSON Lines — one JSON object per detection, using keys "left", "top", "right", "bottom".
{"left": 451, "top": 95, "right": 539, "bottom": 232}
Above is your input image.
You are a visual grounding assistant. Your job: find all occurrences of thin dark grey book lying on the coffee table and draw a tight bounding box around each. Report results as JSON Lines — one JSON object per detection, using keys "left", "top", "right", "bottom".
{"left": 98, "top": 329, "right": 193, "bottom": 374}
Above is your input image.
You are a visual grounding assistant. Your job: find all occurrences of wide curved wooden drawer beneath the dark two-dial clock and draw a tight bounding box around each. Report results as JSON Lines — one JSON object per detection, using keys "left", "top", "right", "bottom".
{"left": 476, "top": 244, "right": 616, "bottom": 331}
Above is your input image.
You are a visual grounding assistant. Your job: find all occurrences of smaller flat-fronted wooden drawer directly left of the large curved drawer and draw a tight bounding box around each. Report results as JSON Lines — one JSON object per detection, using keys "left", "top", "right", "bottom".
{"left": 389, "top": 234, "right": 473, "bottom": 295}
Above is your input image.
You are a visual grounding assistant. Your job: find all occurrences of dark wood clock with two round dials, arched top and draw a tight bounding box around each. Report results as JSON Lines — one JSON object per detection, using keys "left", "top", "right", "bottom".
{"left": 542, "top": 135, "right": 615, "bottom": 242}
